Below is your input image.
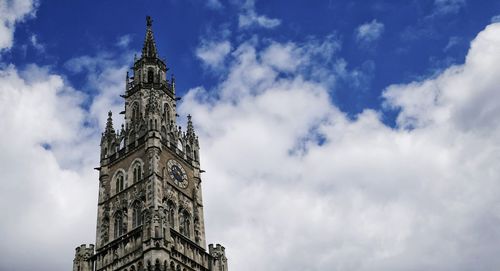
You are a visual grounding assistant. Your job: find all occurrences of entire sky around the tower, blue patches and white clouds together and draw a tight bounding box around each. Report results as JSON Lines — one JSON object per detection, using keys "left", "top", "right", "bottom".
{"left": 0, "top": 0, "right": 500, "bottom": 271}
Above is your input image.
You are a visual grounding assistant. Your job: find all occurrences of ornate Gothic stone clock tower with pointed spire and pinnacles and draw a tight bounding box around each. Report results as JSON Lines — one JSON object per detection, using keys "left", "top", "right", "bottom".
{"left": 73, "top": 16, "right": 227, "bottom": 271}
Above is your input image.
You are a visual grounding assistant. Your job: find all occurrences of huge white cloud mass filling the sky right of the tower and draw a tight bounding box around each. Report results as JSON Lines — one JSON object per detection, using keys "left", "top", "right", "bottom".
{"left": 179, "top": 22, "right": 500, "bottom": 271}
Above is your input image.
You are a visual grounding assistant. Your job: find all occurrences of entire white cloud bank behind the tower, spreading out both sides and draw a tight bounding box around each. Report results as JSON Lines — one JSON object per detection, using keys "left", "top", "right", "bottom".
{"left": 0, "top": 2, "right": 500, "bottom": 271}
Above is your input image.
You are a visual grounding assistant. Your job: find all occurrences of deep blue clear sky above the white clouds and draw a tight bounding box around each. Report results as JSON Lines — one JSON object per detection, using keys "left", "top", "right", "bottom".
{"left": 7, "top": 0, "right": 500, "bottom": 118}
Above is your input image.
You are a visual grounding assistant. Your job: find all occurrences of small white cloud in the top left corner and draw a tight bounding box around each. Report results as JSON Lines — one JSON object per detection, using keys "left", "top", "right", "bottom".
{"left": 0, "top": 0, "right": 38, "bottom": 51}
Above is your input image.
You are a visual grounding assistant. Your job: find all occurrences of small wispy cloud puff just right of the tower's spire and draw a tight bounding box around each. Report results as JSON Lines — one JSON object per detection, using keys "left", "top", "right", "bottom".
{"left": 196, "top": 40, "right": 231, "bottom": 70}
